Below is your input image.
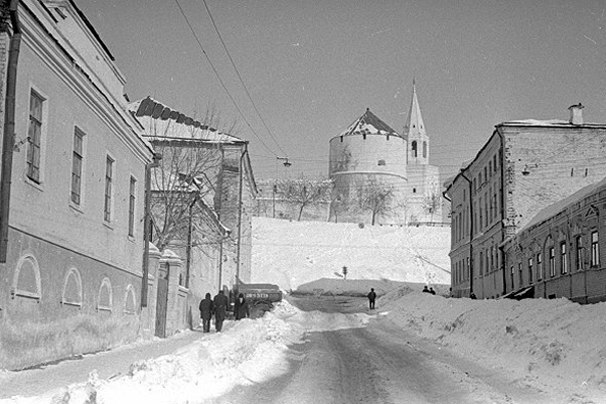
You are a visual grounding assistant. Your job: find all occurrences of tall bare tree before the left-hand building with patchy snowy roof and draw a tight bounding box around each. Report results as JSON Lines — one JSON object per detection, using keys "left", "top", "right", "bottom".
{"left": 144, "top": 109, "right": 235, "bottom": 250}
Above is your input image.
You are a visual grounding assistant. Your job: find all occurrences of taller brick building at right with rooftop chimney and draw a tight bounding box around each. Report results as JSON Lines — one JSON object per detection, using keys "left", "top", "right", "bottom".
{"left": 444, "top": 104, "right": 606, "bottom": 298}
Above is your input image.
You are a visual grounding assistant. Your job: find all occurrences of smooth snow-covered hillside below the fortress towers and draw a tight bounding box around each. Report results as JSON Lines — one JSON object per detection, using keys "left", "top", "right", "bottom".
{"left": 252, "top": 217, "right": 450, "bottom": 290}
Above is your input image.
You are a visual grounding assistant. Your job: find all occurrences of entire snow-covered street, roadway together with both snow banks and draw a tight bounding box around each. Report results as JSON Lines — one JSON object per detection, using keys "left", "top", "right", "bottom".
{"left": 0, "top": 288, "right": 606, "bottom": 404}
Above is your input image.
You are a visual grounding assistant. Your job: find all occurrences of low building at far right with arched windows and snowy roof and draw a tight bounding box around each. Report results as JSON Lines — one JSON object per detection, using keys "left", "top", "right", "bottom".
{"left": 503, "top": 179, "right": 606, "bottom": 303}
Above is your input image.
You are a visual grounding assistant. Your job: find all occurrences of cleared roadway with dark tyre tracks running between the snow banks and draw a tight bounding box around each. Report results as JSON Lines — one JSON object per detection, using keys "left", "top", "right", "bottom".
{"left": 211, "top": 298, "right": 548, "bottom": 404}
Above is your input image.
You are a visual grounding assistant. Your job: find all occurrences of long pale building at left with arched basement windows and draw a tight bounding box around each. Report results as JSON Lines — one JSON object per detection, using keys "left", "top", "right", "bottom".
{"left": 0, "top": 0, "right": 153, "bottom": 369}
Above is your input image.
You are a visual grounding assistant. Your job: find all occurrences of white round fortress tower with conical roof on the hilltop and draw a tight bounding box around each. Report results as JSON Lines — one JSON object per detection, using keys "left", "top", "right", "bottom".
{"left": 328, "top": 109, "right": 408, "bottom": 224}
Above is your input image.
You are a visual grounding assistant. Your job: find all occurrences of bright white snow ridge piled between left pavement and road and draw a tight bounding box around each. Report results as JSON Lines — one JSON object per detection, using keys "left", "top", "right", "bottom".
{"left": 0, "top": 301, "right": 371, "bottom": 404}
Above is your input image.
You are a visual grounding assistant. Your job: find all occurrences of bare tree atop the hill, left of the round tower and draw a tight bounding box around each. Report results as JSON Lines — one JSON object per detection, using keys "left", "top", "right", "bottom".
{"left": 276, "top": 175, "right": 333, "bottom": 221}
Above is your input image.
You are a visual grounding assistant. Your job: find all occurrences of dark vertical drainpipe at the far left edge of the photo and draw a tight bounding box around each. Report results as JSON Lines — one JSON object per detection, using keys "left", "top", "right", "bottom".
{"left": 0, "top": 0, "right": 21, "bottom": 263}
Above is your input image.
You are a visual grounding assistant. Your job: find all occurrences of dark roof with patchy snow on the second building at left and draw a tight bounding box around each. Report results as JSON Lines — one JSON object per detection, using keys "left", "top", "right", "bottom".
{"left": 127, "top": 97, "right": 245, "bottom": 143}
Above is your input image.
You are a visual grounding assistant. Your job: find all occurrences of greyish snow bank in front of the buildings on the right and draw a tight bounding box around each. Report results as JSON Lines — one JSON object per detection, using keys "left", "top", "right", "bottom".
{"left": 378, "top": 290, "right": 606, "bottom": 402}
